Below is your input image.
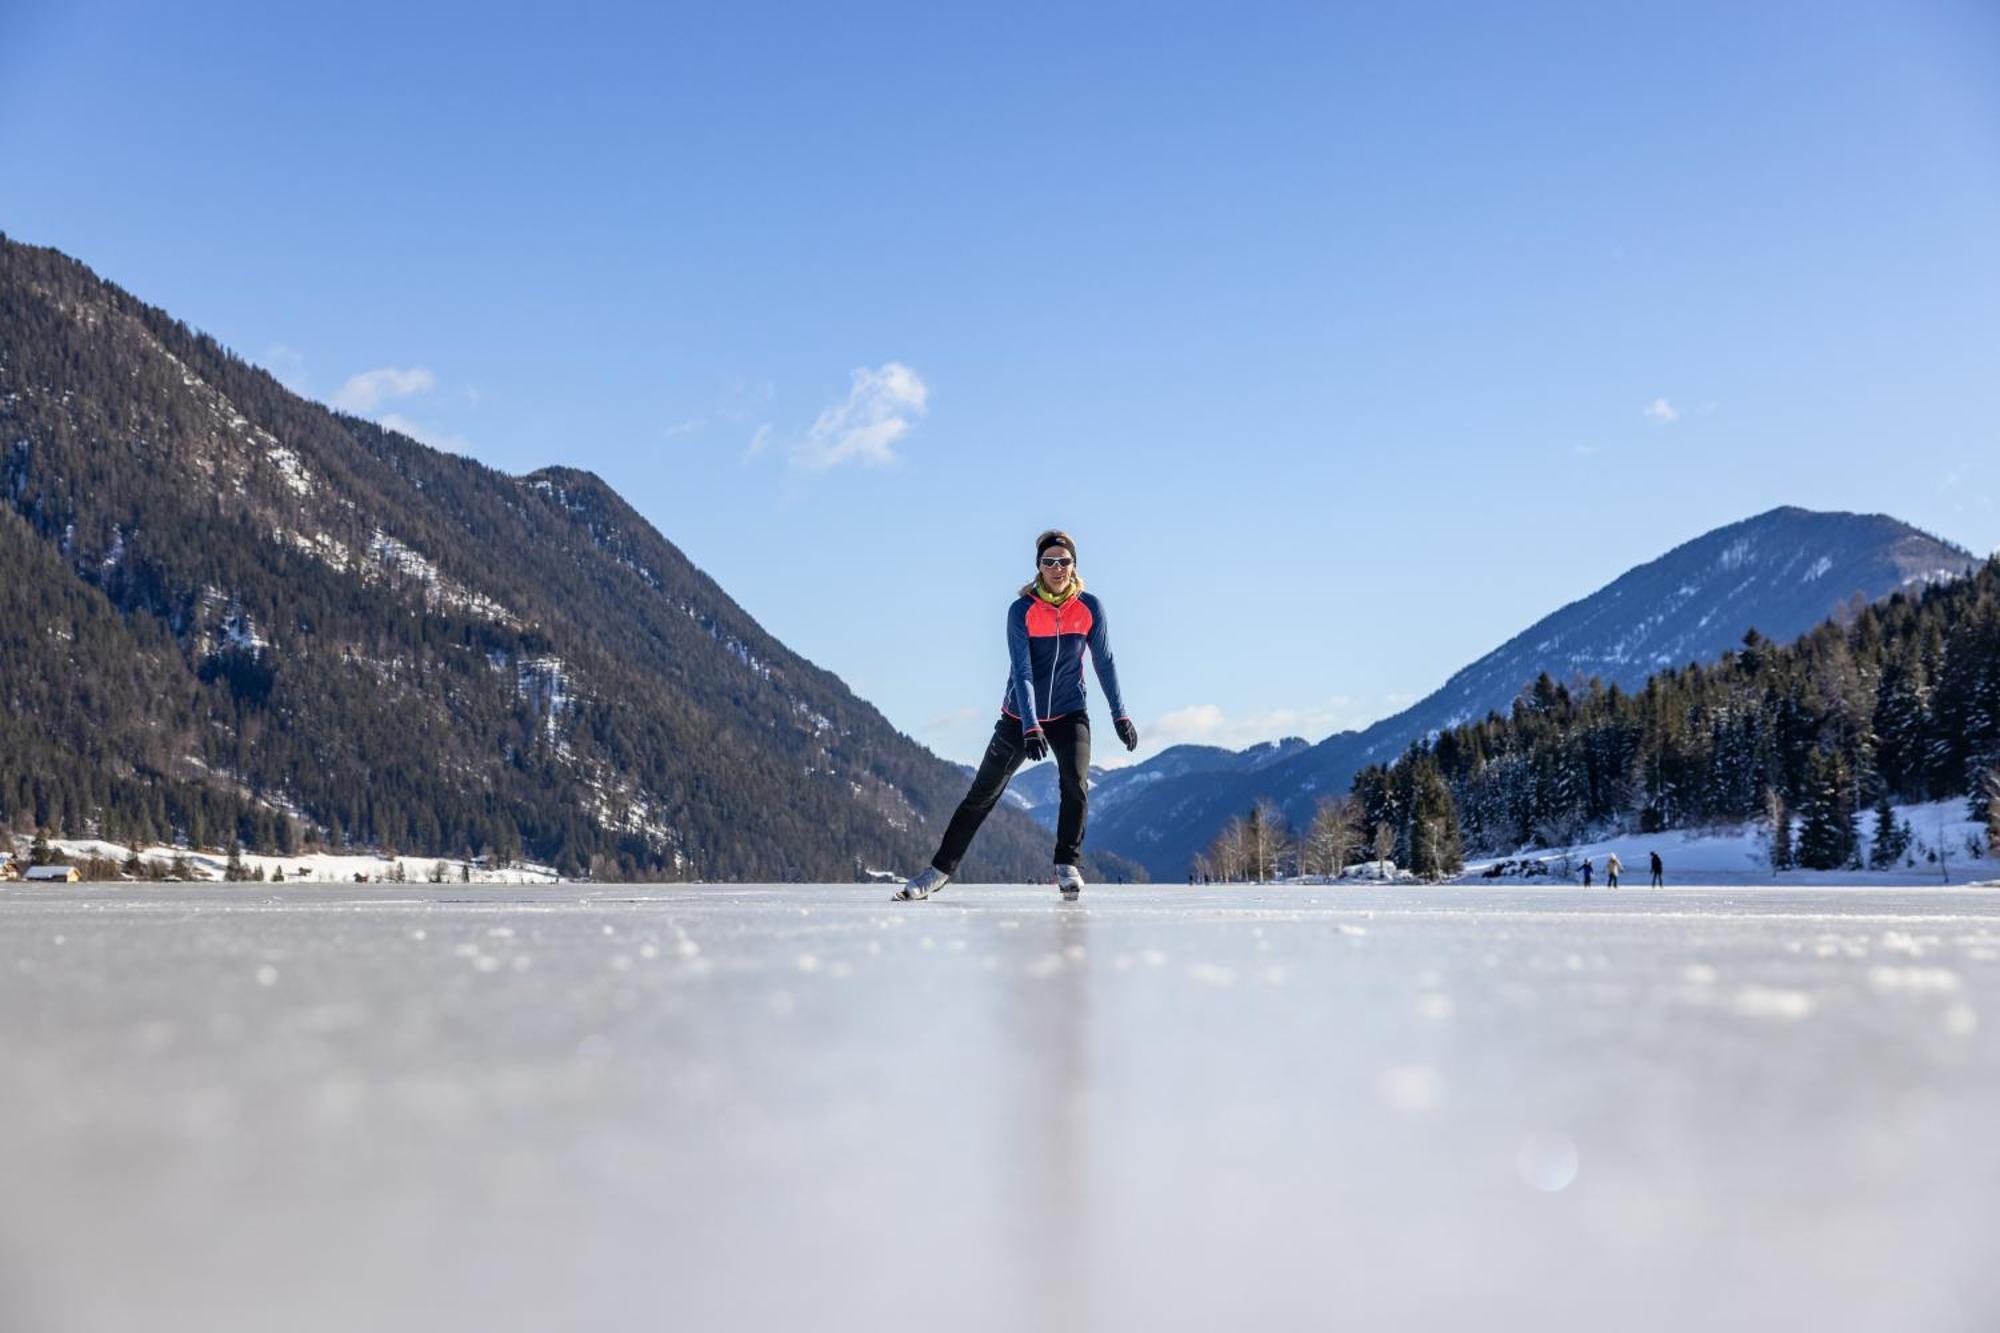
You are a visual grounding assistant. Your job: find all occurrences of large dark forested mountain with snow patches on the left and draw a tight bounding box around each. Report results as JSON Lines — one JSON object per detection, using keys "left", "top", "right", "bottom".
{"left": 0, "top": 236, "right": 1080, "bottom": 879}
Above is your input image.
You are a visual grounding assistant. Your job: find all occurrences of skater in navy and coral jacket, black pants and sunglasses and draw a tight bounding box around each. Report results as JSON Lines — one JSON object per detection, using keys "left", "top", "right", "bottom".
{"left": 896, "top": 528, "right": 1138, "bottom": 901}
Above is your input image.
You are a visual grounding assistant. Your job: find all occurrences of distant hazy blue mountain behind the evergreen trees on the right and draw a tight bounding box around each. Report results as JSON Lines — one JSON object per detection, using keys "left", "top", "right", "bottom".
{"left": 1090, "top": 508, "right": 1978, "bottom": 879}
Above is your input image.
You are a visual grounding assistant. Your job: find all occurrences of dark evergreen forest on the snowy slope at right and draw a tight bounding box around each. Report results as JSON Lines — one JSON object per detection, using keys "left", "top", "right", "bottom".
{"left": 1354, "top": 556, "right": 2000, "bottom": 869}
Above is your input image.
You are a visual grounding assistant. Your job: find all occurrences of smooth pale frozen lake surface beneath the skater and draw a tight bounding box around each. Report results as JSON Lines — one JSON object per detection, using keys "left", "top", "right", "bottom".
{"left": 0, "top": 885, "right": 2000, "bottom": 1333}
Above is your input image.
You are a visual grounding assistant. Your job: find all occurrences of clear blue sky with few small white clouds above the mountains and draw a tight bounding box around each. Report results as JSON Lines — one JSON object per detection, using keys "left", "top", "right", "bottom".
{"left": 0, "top": 0, "right": 2000, "bottom": 761}
